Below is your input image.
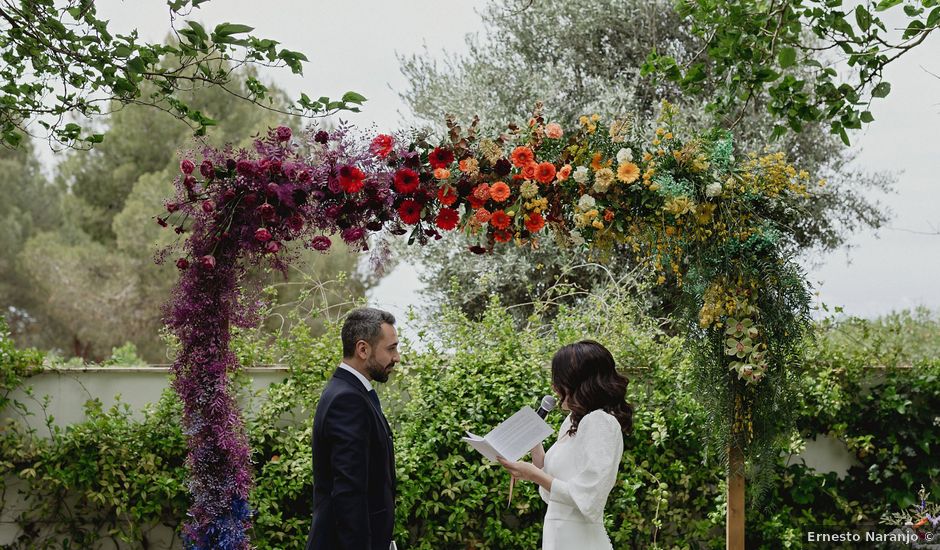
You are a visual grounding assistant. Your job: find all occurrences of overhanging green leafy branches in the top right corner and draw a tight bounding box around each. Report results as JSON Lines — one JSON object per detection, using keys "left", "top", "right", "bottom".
{"left": 642, "top": 0, "right": 940, "bottom": 145}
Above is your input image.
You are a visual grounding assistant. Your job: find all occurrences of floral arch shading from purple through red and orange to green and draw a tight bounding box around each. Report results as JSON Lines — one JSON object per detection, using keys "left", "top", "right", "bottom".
{"left": 157, "top": 102, "right": 812, "bottom": 549}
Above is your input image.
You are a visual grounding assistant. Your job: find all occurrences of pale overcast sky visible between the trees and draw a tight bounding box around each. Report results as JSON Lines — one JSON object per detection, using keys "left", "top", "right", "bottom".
{"left": 90, "top": 0, "right": 940, "bottom": 324}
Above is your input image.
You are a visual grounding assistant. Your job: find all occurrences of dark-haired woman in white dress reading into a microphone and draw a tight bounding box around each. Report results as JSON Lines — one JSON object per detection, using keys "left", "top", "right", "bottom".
{"left": 500, "top": 340, "right": 633, "bottom": 550}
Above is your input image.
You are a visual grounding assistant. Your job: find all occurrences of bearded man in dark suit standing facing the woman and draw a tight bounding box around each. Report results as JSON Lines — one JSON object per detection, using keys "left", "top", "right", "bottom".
{"left": 307, "top": 308, "right": 401, "bottom": 550}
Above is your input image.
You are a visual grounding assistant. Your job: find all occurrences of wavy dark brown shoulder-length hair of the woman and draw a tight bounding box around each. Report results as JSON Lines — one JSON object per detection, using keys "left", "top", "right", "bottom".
{"left": 552, "top": 340, "right": 633, "bottom": 435}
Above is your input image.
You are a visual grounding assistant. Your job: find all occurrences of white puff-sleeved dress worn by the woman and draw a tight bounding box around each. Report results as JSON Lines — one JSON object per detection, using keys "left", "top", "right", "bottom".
{"left": 539, "top": 410, "right": 623, "bottom": 550}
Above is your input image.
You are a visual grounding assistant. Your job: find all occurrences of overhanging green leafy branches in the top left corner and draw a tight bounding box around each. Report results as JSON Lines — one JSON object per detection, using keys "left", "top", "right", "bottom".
{"left": 0, "top": 0, "right": 365, "bottom": 148}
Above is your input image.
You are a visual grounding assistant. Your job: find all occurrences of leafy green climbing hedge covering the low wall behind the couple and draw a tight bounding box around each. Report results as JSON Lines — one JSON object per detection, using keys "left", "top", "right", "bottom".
{"left": 0, "top": 306, "right": 940, "bottom": 550}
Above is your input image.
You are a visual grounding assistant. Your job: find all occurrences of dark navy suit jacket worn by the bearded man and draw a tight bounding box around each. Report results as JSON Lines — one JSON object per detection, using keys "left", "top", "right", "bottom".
{"left": 307, "top": 369, "right": 396, "bottom": 550}
